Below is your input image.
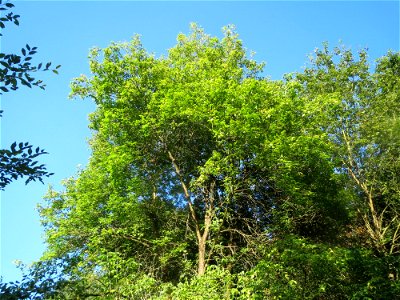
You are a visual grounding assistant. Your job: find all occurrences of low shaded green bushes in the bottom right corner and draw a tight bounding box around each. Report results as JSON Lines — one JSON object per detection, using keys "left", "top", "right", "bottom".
{"left": 235, "top": 236, "right": 400, "bottom": 299}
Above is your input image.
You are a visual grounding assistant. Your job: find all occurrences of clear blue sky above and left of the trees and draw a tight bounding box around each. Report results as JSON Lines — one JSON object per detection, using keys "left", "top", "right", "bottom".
{"left": 0, "top": 1, "right": 399, "bottom": 281}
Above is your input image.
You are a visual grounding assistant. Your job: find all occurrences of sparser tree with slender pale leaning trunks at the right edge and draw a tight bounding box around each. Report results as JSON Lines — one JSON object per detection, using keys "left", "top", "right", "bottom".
{"left": 296, "top": 45, "right": 400, "bottom": 255}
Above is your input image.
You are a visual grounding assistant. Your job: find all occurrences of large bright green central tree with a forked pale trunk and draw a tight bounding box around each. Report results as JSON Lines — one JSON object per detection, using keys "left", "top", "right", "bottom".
{"left": 36, "top": 26, "right": 344, "bottom": 292}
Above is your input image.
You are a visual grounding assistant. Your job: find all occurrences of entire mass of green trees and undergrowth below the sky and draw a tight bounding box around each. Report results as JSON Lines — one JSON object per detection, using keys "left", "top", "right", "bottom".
{"left": 1, "top": 25, "right": 400, "bottom": 299}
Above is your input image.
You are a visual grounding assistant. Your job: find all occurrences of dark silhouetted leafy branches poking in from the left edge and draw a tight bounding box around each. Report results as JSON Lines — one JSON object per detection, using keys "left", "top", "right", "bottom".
{"left": 0, "top": 1, "right": 60, "bottom": 190}
